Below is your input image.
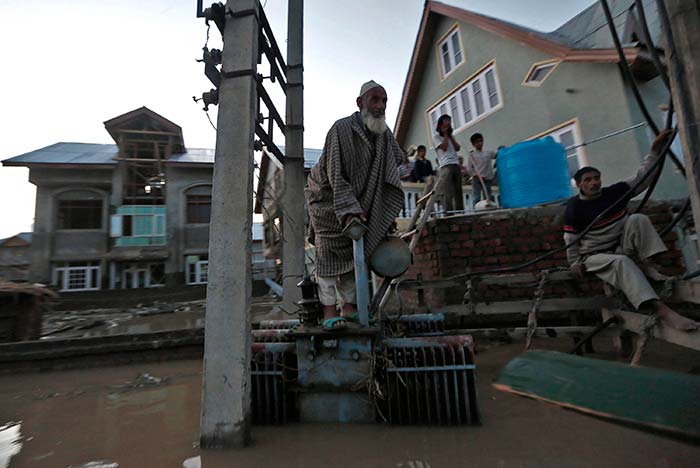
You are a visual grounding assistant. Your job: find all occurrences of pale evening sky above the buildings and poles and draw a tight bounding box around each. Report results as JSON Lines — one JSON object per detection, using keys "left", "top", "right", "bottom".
{"left": 0, "top": 0, "right": 594, "bottom": 238}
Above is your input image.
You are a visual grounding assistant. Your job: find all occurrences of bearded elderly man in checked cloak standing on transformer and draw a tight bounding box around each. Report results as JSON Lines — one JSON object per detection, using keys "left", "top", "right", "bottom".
{"left": 304, "top": 81, "right": 404, "bottom": 329}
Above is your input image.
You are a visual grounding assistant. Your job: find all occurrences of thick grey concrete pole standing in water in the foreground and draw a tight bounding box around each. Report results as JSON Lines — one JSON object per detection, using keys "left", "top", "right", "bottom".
{"left": 200, "top": 0, "right": 259, "bottom": 448}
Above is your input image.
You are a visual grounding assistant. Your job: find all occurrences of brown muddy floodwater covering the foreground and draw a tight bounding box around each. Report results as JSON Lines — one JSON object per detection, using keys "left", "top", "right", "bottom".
{"left": 0, "top": 339, "right": 700, "bottom": 468}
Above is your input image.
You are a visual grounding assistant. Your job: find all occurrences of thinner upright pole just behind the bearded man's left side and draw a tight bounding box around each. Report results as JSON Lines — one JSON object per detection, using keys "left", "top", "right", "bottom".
{"left": 282, "top": 0, "right": 305, "bottom": 310}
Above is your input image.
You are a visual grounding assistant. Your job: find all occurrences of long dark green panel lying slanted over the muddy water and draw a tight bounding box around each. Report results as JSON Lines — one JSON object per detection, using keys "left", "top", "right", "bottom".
{"left": 493, "top": 351, "right": 700, "bottom": 440}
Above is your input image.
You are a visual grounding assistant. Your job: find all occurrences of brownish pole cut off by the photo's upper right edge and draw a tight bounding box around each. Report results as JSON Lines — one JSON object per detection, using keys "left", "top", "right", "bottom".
{"left": 656, "top": 0, "right": 700, "bottom": 230}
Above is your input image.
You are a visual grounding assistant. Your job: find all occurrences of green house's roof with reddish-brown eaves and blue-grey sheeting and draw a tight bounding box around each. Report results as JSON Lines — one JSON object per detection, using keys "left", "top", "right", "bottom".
{"left": 394, "top": 0, "right": 644, "bottom": 144}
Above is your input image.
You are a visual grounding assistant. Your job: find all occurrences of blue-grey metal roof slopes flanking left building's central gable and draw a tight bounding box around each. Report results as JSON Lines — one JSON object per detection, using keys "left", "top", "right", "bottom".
{"left": 2, "top": 143, "right": 214, "bottom": 169}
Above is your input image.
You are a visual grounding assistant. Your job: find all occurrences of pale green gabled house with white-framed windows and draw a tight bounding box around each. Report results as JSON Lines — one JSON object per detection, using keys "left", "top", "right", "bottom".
{"left": 394, "top": 0, "right": 687, "bottom": 199}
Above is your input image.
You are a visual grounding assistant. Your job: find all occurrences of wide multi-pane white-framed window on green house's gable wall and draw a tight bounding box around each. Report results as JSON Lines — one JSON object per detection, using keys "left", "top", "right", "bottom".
{"left": 426, "top": 60, "right": 503, "bottom": 141}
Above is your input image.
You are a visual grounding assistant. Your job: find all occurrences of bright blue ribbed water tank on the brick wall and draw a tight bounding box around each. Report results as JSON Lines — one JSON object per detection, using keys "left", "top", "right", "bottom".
{"left": 496, "top": 137, "right": 571, "bottom": 208}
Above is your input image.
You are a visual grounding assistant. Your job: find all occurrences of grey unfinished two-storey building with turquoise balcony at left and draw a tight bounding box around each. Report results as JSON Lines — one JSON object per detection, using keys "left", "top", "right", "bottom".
{"left": 3, "top": 107, "right": 274, "bottom": 291}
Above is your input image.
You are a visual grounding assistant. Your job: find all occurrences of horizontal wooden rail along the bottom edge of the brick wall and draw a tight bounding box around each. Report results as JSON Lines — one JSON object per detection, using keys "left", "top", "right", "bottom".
{"left": 440, "top": 296, "right": 610, "bottom": 315}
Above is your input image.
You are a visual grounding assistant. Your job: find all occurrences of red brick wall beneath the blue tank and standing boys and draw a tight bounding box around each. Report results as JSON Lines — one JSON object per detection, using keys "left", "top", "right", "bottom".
{"left": 401, "top": 203, "right": 685, "bottom": 310}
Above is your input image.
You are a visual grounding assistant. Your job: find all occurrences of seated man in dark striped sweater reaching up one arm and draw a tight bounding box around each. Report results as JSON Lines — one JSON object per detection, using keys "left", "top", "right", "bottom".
{"left": 564, "top": 131, "right": 700, "bottom": 331}
